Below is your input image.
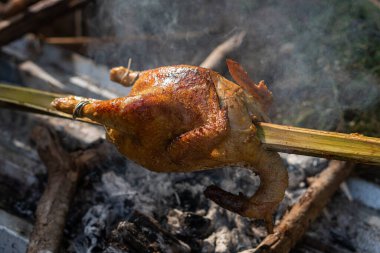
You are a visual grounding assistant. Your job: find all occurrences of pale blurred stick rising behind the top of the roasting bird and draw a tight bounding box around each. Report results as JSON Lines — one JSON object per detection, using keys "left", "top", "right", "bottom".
{"left": 199, "top": 31, "right": 246, "bottom": 70}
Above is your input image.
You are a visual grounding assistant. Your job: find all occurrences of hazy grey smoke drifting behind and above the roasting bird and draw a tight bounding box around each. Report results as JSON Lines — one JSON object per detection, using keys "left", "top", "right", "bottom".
{"left": 88, "top": 0, "right": 380, "bottom": 130}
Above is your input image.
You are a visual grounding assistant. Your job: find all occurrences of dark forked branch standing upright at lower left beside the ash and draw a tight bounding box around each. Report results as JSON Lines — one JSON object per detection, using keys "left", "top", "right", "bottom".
{"left": 28, "top": 127, "right": 107, "bottom": 253}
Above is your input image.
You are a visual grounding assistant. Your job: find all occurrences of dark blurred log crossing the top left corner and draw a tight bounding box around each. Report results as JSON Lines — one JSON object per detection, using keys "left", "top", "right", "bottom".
{"left": 0, "top": 0, "right": 90, "bottom": 46}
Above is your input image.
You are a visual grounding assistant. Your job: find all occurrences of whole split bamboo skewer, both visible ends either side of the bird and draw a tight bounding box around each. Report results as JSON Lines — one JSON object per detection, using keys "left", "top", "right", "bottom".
{"left": 0, "top": 84, "right": 380, "bottom": 165}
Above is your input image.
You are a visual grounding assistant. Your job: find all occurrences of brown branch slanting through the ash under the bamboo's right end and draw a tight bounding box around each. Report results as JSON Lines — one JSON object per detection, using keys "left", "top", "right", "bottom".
{"left": 245, "top": 161, "right": 354, "bottom": 253}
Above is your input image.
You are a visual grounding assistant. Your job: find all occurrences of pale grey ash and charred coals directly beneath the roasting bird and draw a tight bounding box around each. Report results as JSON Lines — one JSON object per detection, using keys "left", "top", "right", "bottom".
{"left": 63, "top": 140, "right": 327, "bottom": 252}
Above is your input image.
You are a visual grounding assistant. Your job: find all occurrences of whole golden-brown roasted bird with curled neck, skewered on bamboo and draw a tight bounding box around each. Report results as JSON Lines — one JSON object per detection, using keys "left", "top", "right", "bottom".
{"left": 53, "top": 60, "right": 288, "bottom": 232}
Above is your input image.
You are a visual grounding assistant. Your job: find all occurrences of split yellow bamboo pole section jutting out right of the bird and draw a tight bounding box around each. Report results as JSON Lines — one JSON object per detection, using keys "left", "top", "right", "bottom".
{"left": 257, "top": 123, "right": 380, "bottom": 165}
